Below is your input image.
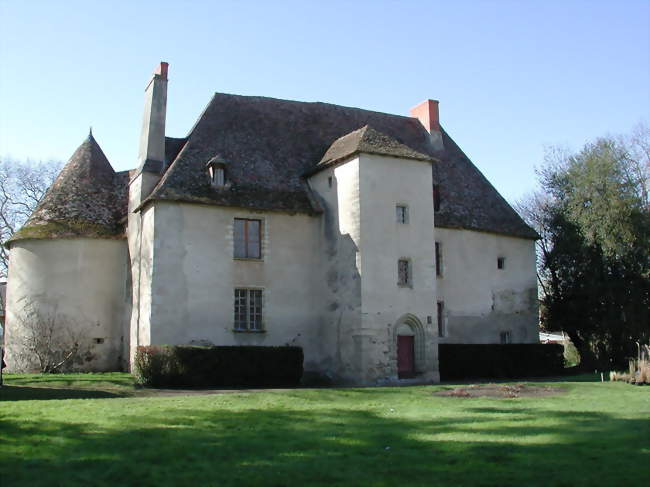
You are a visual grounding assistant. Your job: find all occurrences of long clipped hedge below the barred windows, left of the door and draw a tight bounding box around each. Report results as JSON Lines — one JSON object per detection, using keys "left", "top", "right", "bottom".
{"left": 133, "top": 345, "right": 303, "bottom": 387}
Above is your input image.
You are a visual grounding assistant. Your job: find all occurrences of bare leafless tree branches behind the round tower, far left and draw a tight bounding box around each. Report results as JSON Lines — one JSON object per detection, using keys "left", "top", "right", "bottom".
{"left": 0, "top": 159, "right": 63, "bottom": 277}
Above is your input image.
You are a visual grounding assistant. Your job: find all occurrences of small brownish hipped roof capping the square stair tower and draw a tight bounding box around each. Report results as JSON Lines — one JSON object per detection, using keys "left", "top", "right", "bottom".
{"left": 318, "top": 125, "right": 433, "bottom": 167}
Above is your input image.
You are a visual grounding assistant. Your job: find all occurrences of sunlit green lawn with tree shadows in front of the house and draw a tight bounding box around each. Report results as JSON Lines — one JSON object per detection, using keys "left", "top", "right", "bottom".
{"left": 0, "top": 373, "right": 650, "bottom": 487}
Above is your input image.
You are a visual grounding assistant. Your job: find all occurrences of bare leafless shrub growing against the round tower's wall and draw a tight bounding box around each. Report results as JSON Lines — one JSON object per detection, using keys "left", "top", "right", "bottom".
{"left": 12, "top": 304, "right": 93, "bottom": 373}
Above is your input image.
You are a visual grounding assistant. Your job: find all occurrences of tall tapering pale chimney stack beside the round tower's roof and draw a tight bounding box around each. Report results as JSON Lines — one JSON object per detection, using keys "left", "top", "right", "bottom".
{"left": 138, "top": 62, "right": 169, "bottom": 174}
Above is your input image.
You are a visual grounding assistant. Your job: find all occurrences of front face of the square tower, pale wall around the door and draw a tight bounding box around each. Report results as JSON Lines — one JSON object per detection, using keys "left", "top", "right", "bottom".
{"left": 360, "top": 154, "right": 439, "bottom": 381}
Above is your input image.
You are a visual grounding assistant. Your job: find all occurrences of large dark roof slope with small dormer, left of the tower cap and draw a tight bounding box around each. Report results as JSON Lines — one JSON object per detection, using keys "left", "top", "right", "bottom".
{"left": 144, "top": 93, "right": 428, "bottom": 212}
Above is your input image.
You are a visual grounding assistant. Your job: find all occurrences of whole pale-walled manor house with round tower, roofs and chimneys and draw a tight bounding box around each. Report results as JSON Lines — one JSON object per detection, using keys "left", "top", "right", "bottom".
{"left": 6, "top": 63, "right": 538, "bottom": 384}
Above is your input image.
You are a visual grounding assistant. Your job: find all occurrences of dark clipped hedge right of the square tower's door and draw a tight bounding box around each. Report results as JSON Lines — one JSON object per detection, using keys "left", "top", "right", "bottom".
{"left": 438, "top": 343, "right": 564, "bottom": 380}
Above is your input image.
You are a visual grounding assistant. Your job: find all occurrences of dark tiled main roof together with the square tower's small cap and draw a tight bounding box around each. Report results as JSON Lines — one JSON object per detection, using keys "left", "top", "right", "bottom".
{"left": 149, "top": 93, "right": 537, "bottom": 238}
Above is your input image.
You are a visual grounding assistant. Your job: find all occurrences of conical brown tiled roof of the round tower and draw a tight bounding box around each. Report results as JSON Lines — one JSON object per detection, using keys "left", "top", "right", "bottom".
{"left": 10, "top": 134, "right": 128, "bottom": 242}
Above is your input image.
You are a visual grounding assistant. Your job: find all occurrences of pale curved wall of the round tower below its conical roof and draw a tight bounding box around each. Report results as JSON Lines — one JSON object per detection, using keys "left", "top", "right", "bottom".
{"left": 5, "top": 238, "right": 128, "bottom": 371}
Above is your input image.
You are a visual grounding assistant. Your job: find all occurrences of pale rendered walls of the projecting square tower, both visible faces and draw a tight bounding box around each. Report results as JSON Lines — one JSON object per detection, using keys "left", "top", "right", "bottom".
{"left": 309, "top": 154, "right": 439, "bottom": 384}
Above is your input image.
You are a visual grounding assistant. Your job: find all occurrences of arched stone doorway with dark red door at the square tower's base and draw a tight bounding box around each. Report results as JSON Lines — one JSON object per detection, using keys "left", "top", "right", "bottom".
{"left": 394, "top": 314, "right": 424, "bottom": 379}
